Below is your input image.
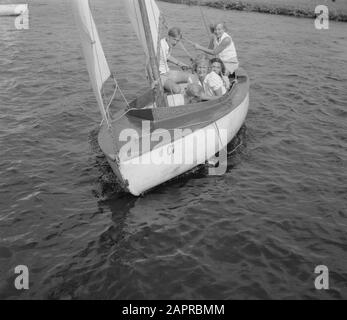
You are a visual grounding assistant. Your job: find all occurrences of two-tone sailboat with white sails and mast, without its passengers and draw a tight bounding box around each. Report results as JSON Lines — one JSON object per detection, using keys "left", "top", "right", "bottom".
{"left": 72, "top": 0, "right": 249, "bottom": 196}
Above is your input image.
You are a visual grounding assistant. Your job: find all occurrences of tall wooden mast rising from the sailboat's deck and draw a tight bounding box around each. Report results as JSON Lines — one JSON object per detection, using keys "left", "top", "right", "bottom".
{"left": 138, "top": 0, "right": 167, "bottom": 107}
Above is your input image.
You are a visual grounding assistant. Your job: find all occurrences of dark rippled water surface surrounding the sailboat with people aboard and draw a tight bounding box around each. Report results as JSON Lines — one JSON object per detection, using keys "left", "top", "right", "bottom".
{"left": 0, "top": 0, "right": 347, "bottom": 299}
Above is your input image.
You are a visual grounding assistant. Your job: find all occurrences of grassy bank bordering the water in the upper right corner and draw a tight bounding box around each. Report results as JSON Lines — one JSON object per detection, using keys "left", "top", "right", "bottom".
{"left": 161, "top": 0, "right": 347, "bottom": 22}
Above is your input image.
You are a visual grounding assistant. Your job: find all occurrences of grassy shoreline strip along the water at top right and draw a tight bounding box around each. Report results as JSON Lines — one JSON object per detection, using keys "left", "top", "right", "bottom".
{"left": 159, "top": 0, "right": 347, "bottom": 22}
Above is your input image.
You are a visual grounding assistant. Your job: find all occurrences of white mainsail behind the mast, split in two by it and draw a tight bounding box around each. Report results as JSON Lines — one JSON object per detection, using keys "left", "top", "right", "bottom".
{"left": 123, "top": 0, "right": 160, "bottom": 57}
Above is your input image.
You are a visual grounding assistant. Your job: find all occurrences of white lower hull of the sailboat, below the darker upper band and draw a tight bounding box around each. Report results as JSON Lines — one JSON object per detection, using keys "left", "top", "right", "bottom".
{"left": 106, "top": 94, "right": 249, "bottom": 196}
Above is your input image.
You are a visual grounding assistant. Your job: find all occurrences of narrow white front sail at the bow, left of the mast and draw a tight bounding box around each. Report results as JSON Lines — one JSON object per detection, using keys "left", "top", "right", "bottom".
{"left": 72, "top": 0, "right": 111, "bottom": 120}
